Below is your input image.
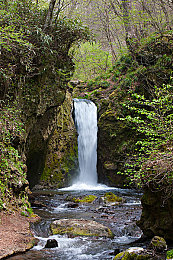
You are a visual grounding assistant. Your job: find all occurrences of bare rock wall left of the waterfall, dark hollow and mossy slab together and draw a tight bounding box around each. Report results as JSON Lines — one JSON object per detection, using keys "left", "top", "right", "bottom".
{"left": 25, "top": 82, "right": 77, "bottom": 187}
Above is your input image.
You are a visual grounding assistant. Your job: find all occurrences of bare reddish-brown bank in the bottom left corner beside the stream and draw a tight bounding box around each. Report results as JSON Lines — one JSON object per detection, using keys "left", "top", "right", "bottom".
{"left": 0, "top": 211, "right": 39, "bottom": 259}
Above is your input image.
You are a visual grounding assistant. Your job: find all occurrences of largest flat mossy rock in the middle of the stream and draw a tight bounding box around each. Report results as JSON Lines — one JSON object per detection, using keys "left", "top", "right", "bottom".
{"left": 51, "top": 219, "right": 113, "bottom": 238}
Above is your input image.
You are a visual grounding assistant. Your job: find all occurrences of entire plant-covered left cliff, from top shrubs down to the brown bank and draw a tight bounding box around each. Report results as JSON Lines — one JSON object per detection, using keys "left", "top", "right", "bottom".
{"left": 0, "top": 0, "right": 88, "bottom": 209}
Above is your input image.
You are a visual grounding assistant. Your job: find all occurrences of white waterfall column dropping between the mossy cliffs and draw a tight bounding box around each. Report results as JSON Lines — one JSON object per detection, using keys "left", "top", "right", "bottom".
{"left": 74, "top": 99, "right": 97, "bottom": 185}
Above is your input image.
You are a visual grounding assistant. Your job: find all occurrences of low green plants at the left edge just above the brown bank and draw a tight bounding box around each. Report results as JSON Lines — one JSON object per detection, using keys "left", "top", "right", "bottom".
{"left": 0, "top": 102, "right": 28, "bottom": 209}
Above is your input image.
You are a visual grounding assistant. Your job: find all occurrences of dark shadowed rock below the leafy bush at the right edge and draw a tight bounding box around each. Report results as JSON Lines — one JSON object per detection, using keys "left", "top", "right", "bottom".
{"left": 137, "top": 189, "right": 173, "bottom": 241}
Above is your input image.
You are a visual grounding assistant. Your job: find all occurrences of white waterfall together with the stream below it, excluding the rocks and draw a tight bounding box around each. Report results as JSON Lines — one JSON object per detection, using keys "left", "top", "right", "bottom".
{"left": 10, "top": 99, "right": 141, "bottom": 260}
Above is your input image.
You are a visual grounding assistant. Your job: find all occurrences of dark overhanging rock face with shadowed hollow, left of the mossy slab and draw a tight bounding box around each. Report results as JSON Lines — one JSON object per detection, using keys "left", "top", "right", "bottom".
{"left": 21, "top": 74, "right": 66, "bottom": 187}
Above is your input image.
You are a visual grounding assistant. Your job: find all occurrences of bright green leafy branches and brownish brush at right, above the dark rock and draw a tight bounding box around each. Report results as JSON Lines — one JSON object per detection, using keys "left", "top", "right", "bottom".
{"left": 119, "top": 80, "right": 173, "bottom": 194}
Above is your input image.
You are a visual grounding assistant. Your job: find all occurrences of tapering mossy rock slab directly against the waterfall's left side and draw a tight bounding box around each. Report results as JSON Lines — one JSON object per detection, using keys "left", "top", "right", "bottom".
{"left": 41, "top": 91, "right": 78, "bottom": 188}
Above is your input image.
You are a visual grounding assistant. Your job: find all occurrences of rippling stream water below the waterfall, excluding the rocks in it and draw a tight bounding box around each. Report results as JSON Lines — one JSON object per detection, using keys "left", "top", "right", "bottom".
{"left": 9, "top": 188, "right": 141, "bottom": 260}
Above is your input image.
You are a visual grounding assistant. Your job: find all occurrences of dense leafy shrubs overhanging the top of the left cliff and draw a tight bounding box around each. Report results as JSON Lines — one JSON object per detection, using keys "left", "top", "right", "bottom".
{"left": 0, "top": 0, "right": 89, "bottom": 99}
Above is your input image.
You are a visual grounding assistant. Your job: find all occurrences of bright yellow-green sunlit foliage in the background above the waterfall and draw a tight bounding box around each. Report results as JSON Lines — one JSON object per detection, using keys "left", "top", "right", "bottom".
{"left": 70, "top": 42, "right": 112, "bottom": 81}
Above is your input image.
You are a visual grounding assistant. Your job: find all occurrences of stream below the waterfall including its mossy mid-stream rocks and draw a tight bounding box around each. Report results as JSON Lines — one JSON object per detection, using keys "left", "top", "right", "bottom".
{"left": 9, "top": 188, "right": 145, "bottom": 260}
